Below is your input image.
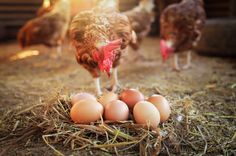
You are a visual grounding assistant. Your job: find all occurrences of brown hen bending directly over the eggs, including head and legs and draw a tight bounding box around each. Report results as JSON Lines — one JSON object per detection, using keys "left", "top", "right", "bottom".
{"left": 69, "top": 0, "right": 132, "bottom": 95}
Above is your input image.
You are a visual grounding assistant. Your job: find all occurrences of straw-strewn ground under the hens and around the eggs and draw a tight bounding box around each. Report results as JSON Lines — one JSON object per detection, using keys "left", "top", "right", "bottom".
{"left": 0, "top": 38, "right": 236, "bottom": 156}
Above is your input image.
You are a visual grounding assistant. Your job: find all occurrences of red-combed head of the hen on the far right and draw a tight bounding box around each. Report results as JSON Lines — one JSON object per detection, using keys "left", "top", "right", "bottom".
{"left": 160, "top": 40, "right": 174, "bottom": 61}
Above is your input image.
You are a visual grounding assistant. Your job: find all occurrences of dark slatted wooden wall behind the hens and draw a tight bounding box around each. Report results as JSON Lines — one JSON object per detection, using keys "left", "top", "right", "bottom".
{"left": 0, "top": 0, "right": 236, "bottom": 40}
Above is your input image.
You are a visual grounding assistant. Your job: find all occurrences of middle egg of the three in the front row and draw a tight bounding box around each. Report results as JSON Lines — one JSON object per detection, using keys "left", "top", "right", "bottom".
{"left": 104, "top": 100, "right": 129, "bottom": 121}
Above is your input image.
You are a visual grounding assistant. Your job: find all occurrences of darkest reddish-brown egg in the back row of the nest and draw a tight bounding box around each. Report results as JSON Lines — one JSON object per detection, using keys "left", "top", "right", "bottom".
{"left": 120, "top": 89, "right": 144, "bottom": 109}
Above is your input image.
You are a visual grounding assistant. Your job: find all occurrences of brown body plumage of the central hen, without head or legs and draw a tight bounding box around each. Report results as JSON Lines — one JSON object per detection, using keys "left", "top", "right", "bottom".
{"left": 70, "top": 1, "right": 132, "bottom": 77}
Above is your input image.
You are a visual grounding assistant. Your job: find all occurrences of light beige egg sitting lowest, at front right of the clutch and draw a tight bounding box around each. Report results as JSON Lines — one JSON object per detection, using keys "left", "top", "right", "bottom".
{"left": 133, "top": 101, "right": 160, "bottom": 128}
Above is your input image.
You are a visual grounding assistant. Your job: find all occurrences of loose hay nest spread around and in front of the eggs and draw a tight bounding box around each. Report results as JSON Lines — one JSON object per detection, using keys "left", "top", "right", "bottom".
{"left": 0, "top": 92, "right": 236, "bottom": 155}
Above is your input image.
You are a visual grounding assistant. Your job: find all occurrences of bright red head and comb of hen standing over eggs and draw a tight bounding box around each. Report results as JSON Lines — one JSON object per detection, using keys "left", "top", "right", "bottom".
{"left": 93, "top": 39, "right": 122, "bottom": 76}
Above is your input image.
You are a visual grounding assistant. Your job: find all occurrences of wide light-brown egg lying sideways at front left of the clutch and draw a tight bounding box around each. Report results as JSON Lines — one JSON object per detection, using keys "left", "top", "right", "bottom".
{"left": 70, "top": 99, "right": 104, "bottom": 124}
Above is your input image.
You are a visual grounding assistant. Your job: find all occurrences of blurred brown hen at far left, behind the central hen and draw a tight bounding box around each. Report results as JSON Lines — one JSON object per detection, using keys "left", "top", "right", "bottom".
{"left": 18, "top": 0, "right": 70, "bottom": 55}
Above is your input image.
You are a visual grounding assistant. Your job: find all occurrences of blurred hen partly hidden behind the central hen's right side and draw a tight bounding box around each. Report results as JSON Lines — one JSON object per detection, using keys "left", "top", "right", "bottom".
{"left": 124, "top": 0, "right": 155, "bottom": 58}
